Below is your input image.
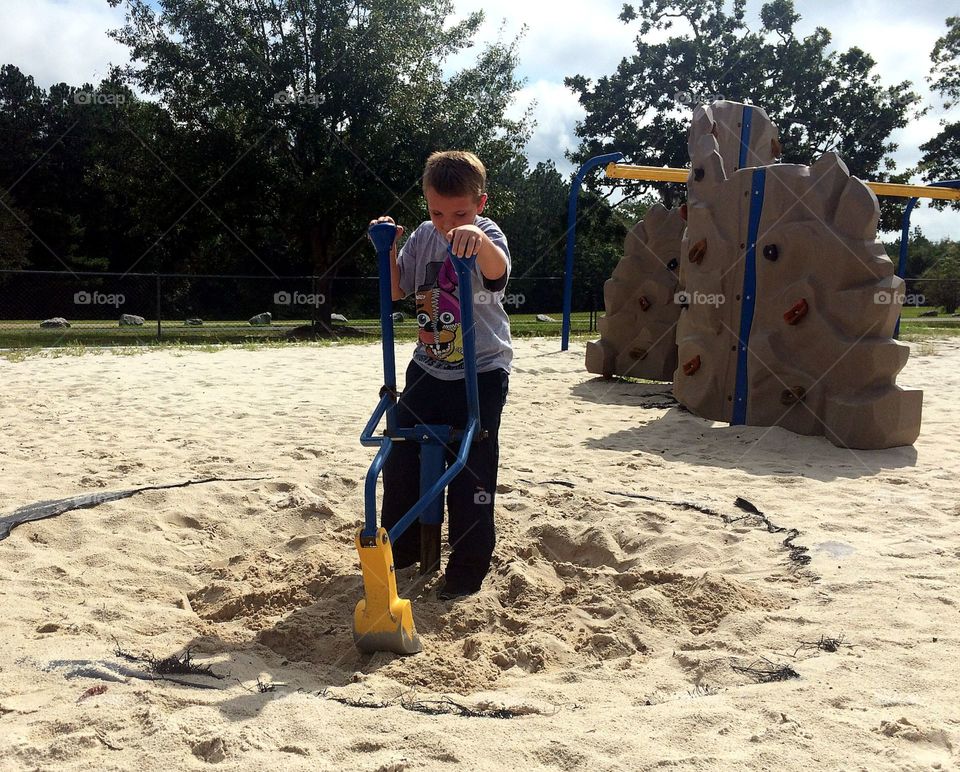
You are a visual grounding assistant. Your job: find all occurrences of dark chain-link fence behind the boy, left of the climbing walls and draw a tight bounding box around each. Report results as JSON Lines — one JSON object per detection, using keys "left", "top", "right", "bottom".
{"left": 0, "top": 270, "right": 602, "bottom": 348}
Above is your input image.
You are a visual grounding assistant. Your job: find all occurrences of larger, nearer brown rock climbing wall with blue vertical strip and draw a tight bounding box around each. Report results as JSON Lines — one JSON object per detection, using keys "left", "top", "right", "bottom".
{"left": 674, "top": 128, "right": 922, "bottom": 448}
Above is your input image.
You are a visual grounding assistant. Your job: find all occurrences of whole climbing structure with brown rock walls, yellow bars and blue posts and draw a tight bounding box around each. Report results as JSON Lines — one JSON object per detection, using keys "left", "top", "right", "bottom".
{"left": 562, "top": 102, "right": 960, "bottom": 448}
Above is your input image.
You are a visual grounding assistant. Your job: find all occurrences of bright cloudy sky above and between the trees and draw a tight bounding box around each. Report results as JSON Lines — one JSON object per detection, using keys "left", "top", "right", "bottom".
{"left": 0, "top": 0, "right": 960, "bottom": 239}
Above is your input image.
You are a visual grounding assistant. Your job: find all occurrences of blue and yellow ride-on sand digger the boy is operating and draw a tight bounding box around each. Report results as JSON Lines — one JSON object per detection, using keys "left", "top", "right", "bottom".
{"left": 353, "top": 223, "right": 482, "bottom": 654}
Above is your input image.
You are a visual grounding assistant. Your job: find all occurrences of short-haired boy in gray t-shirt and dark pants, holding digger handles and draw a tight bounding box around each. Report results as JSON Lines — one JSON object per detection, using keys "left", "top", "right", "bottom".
{"left": 371, "top": 151, "right": 513, "bottom": 600}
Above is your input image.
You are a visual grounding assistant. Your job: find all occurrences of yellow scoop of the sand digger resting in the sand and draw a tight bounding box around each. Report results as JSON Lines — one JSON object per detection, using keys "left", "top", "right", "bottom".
{"left": 353, "top": 528, "right": 423, "bottom": 654}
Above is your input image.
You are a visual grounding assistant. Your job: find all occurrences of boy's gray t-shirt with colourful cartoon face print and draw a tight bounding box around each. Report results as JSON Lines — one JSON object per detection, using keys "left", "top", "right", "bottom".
{"left": 397, "top": 217, "right": 513, "bottom": 381}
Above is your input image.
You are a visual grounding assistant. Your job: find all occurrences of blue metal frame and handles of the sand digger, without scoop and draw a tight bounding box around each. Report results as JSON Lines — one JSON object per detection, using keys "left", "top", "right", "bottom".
{"left": 360, "top": 223, "right": 480, "bottom": 542}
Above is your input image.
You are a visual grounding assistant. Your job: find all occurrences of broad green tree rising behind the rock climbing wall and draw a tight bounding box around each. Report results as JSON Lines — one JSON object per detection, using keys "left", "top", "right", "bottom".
{"left": 566, "top": 0, "right": 917, "bottom": 226}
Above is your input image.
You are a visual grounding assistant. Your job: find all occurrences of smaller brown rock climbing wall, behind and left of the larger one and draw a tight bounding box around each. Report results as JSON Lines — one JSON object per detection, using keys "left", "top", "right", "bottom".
{"left": 586, "top": 204, "right": 685, "bottom": 381}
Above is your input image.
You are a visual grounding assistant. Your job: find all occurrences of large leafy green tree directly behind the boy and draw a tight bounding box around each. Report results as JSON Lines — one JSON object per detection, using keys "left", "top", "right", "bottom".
{"left": 110, "top": 0, "right": 527, "bottom": 324}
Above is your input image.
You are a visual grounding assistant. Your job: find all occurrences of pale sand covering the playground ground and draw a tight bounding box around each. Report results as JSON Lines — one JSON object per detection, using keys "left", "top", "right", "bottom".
{"left": 0, "top": 339, "right": 960, "bottom": 771}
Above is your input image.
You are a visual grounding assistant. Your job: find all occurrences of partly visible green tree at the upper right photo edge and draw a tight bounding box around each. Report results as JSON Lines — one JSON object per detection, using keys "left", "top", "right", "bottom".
{"left": 920, "top": 16, "right": 960, "bottom": 209}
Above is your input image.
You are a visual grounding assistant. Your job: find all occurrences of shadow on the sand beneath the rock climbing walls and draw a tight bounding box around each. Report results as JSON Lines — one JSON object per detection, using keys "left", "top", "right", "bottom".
{"left": 571, "top": 378, "right": 917, "bottom": 481}
